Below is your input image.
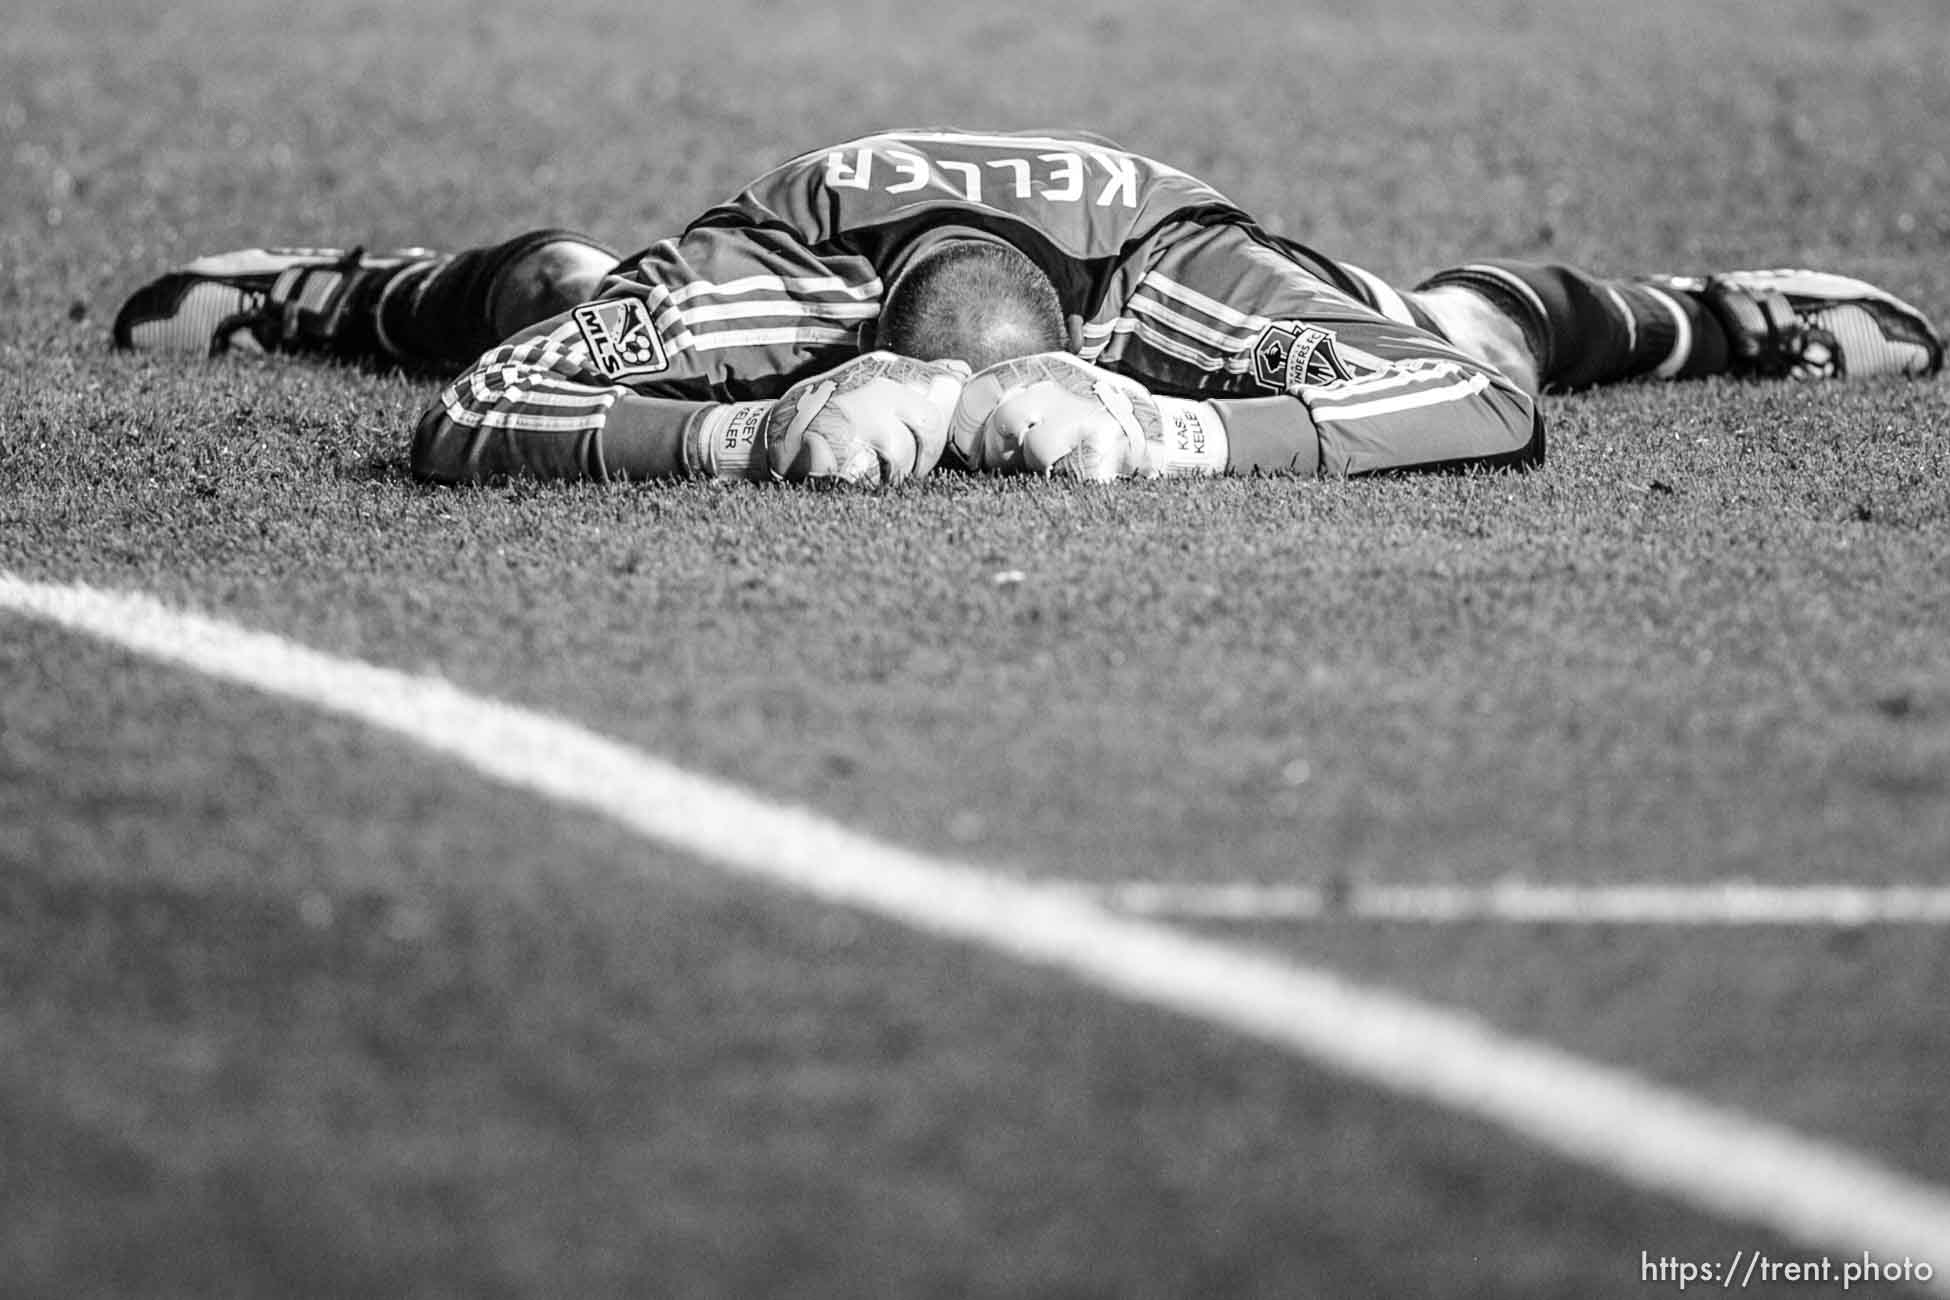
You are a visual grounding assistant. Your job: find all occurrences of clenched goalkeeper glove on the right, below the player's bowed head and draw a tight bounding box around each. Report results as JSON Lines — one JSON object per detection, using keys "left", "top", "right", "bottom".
{"left": 948, "top": 353, "right": 1162, "bottom": 483}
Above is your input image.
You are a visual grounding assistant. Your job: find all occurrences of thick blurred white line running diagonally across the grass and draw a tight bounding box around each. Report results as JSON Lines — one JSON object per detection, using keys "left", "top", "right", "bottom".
{"left": 11, "top": 573, "right": 1950, "bottom": 1294}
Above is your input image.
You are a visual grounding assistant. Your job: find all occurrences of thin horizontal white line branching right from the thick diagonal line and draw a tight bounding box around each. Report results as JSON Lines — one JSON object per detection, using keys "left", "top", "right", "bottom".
{"left": 1099, "top": 881, "right": 1950, "bottom": 930}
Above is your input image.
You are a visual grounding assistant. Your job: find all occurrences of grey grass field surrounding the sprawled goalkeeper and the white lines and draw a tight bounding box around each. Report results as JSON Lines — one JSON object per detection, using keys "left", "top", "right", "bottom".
{"left": 0, "top": 0, "right": 1950, "bottom": 1298}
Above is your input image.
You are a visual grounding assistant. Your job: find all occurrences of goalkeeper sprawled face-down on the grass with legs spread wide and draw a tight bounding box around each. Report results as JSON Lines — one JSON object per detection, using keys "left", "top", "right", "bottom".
{"left": 115, "top": 131, "right": 1944, "bottom": 483}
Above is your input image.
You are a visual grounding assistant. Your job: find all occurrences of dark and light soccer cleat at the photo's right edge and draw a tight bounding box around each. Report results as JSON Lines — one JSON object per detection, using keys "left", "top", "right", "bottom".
{"left": 1659, "top": 271, "right": 1944, "bottom": 380}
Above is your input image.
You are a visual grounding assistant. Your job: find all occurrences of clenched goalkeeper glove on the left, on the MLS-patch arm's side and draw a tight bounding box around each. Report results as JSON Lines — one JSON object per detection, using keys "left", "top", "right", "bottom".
{"left": 764, "top": 353, "right": 969, "bottom": 483}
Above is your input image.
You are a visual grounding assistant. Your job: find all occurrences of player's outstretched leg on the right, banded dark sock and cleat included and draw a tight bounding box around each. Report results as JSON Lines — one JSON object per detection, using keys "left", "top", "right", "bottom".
{"left": 1402, "top": 261, "right": 1944, "bottom": 390}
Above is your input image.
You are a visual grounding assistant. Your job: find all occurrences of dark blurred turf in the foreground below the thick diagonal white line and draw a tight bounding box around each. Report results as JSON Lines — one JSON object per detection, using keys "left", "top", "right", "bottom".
{"left": 0, "top": 630, "right": 1809, "bottom": 1298}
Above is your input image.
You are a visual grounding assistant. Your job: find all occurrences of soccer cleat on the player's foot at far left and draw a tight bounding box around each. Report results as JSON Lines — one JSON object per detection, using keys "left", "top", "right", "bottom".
{"left": 115, "top": 248, "right": 437, "bottom": 361}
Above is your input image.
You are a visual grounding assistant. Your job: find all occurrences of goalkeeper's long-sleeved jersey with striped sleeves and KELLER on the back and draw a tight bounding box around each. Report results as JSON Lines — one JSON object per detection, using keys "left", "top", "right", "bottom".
{"left": 415, "top": 129, "right": 1542, "bottom": 478}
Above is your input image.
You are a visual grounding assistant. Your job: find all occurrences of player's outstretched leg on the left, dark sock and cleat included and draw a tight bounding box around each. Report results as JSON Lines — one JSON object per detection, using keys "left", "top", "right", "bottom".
{"left": 113, "top": 230, "right": 616, "bottom": 368}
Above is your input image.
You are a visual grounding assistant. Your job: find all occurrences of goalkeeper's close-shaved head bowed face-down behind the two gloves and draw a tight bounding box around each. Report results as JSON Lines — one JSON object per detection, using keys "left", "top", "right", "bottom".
{"left": 876, "top": 240, "right": 1067, "bottom": 370}
